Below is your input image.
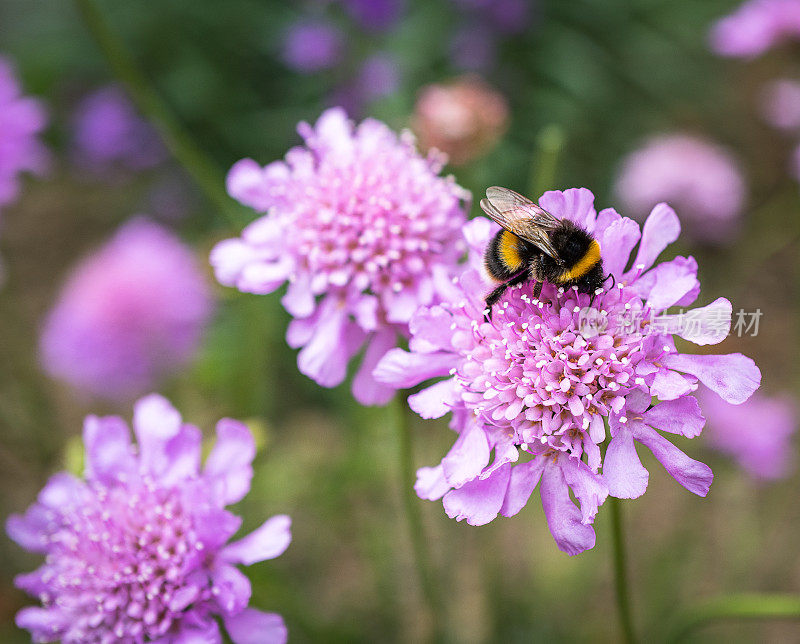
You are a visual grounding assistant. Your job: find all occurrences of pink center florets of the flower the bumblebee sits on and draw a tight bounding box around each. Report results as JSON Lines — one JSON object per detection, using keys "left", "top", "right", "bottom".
{"left": 455, "top": 284, "right": 648, "bottom": 454}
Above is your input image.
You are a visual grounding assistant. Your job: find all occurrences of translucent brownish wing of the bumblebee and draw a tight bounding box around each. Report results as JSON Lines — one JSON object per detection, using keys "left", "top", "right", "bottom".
{"left": 481, "top": 186, "right": 561, "bottom": 261}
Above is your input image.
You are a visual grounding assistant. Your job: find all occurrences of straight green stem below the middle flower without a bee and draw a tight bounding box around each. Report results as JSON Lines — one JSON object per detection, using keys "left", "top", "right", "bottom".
{"left": 393, "top": 392, "right": 444, "bottom": 641}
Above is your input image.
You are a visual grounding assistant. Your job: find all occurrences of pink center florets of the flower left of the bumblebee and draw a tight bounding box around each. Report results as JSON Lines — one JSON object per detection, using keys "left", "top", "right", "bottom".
{"left": 287, "top": 147, "right": 463, "bottom": 304}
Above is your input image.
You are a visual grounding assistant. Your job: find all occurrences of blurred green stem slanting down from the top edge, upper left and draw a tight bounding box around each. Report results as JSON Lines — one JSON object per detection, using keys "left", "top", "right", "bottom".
{"left": 75, "top": 0, "right": 244, "bottom": 229}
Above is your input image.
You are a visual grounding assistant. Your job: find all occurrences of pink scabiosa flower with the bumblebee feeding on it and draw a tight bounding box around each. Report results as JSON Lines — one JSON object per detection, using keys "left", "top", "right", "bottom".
{"left": 375, "top": 188, "right": 761, "bottom": 555}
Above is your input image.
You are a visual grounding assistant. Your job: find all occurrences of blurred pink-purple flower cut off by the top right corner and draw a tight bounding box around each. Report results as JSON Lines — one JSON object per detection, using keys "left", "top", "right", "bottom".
{"left": 710, "top": 0, "right": 800, "bottom": 58}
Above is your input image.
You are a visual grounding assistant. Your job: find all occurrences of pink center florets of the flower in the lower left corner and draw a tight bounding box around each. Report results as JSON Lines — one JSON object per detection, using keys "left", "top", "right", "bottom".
{"left": 41, "top": 483, "right": 208, "bottom": 642}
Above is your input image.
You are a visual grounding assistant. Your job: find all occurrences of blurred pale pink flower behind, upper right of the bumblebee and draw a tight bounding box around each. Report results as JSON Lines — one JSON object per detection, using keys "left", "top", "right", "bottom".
{"left": 616, "top": 134, "right": 745, "bottom": 243}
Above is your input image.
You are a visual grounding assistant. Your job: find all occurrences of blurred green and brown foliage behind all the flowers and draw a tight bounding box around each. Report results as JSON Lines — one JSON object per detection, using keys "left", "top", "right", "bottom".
{"left": 0, "top": 0, "right": 800, "bottom": 642}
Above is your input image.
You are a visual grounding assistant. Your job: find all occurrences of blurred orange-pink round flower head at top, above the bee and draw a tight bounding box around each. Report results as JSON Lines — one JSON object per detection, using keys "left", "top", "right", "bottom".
{"left": 411, "top": 76, "right": 508, "bottom": 165}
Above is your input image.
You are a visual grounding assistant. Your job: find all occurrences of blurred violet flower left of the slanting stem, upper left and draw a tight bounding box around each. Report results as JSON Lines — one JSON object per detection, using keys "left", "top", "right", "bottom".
{"left": 73, "top": 85, "right": 168, "bottom": 175}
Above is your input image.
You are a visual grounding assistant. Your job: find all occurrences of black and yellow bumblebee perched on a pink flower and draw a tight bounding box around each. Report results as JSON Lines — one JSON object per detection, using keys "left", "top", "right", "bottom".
{"left": 481, "top": 186, "right": 608, "bottom": 319}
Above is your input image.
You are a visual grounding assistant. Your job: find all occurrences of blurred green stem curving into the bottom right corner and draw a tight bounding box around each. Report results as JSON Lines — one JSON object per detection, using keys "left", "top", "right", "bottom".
{"left": 667, "top": 593, "right": 800, "bottom": 642}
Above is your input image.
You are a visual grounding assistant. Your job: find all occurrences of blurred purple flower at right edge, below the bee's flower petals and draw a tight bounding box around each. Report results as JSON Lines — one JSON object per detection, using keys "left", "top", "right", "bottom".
{"left": 702, "top": 394, "right": 797, "bottom": 479}
